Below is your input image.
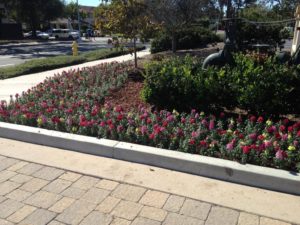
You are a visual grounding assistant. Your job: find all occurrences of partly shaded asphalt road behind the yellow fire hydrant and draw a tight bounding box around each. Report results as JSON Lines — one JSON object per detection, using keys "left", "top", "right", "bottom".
{"left": 0, "top": 37, "right": 108, "bottom": 68}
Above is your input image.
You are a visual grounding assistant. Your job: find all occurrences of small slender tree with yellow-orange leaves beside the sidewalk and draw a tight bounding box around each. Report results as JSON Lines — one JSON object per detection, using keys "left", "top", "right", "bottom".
{"left": 96, "top": 0, "right": 153, "bottom": 68}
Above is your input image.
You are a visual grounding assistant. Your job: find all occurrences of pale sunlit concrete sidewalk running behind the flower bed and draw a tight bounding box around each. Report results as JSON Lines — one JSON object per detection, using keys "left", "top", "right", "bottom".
{"left": 0, "top": 49, "right": 150, "bottom": 101}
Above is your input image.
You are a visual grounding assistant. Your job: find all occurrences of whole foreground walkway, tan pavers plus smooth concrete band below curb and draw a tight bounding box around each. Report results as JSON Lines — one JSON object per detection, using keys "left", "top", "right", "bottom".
{"left": 0, "top": 138, "right": 300, "bottom": 225}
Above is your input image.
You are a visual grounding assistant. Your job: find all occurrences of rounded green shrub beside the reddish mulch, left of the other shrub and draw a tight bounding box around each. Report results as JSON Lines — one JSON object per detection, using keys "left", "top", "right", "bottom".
{"left": 142, "top": 56, "right": 232, "bottom": 111}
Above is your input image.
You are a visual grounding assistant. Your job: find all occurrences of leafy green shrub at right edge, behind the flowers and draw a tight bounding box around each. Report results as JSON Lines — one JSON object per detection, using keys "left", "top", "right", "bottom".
{"left": 226, "top": 54, "right": 300, "bottom": 114}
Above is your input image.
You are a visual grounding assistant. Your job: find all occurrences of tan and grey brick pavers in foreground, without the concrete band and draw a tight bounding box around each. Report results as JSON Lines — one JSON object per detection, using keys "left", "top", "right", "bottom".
{"left": 0, "top": 155, "right": 289, "bottom": 225}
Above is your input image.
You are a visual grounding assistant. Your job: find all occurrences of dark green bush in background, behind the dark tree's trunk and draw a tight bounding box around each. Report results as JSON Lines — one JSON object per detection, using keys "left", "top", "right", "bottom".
{"left": 151, "top": 27, "right": 219, "bottom": 53}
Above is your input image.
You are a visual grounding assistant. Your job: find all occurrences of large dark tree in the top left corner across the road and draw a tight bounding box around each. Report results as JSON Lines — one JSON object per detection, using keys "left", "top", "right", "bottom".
{"left": 2, "top": 0, "right": 64, "bottom": 37}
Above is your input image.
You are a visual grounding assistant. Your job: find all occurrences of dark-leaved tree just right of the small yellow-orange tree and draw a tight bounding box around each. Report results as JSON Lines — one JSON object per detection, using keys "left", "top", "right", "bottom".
{"left": 145, "top": 0, "right": 210, "bottom": 52}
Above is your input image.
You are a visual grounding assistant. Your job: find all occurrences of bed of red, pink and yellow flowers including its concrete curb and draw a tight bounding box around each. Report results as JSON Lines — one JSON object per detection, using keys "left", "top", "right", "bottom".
{"left": 0, "top": 60, "right": 300, "bottom": 194}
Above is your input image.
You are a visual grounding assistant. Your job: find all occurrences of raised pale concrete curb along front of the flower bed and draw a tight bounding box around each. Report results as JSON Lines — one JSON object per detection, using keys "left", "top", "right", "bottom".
{"left": 0, "top": 122, "right": 300, "bottom": 195}
